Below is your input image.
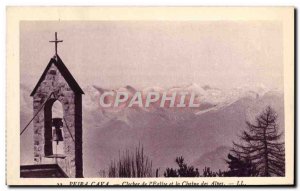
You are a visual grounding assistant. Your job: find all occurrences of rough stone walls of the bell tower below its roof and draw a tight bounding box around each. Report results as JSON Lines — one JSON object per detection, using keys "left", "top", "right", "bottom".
{"left": 33, "top": 64, "right": 82, "bottom": 177}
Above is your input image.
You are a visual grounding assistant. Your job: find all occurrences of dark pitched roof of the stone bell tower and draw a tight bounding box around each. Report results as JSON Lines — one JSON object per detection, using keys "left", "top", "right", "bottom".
{"left": 30, "top": 55, "right": 84, "bottom": 96}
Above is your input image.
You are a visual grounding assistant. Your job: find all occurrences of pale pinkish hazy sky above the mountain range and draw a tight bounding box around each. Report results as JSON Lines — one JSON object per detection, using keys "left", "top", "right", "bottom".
{"left": 20, "top": 21, "right": 283, "bottom": 89}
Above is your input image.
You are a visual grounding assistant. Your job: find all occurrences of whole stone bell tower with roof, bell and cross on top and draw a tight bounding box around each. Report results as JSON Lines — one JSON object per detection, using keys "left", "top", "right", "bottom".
{"left": 31, "top": 33, "right": 84, "bottom": 178}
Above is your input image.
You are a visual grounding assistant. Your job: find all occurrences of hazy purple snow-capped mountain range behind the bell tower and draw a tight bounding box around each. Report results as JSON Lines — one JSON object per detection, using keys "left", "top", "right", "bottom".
{"left": 21, "top": 83, "right": 284, "bottom": 177}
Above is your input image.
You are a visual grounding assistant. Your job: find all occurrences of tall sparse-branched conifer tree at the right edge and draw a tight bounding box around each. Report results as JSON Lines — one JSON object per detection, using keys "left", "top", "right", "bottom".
{"left": 232, "top": 106, "right": 285, "bottom": 176}
